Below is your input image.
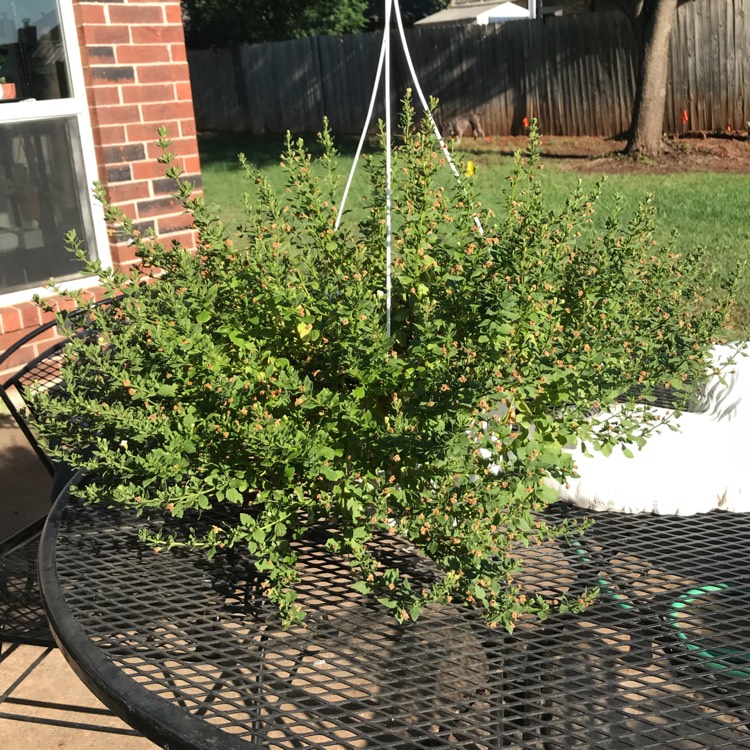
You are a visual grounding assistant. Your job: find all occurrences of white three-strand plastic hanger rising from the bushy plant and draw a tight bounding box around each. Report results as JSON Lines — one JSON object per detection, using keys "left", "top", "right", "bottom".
{"left": 334, "top": 0, "right": 484, "bottom": 337}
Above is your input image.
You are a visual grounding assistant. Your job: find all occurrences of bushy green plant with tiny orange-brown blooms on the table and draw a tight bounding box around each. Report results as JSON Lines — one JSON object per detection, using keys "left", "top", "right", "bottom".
{"left": 30, "top": 100, "right": 740, "bottom": 630}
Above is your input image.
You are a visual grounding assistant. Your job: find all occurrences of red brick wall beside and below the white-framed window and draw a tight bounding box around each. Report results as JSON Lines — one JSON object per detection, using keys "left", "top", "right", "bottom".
{"left": 0, "top": 0, "right": 200, "bottom": 382}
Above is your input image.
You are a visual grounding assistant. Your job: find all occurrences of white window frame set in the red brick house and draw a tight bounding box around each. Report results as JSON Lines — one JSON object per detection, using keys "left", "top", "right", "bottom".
{"left": 0, "top": 0, "right": 112, "bottom": 307}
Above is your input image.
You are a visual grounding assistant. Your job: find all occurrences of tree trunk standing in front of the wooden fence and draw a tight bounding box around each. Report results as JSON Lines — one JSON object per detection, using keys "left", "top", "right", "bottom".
{"left": 626, "top": 0, "right": 678, "bottom": 156}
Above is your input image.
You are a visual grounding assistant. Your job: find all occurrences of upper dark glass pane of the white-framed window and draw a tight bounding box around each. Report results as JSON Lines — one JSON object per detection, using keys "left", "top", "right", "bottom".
{"left": 0, "top": 0, "right": 70, "bottom": 99}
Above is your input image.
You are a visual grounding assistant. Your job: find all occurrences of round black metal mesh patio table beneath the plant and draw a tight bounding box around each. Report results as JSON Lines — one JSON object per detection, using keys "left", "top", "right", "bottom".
{"left": 40, "top": 495, "right": 750, "bottom": 750}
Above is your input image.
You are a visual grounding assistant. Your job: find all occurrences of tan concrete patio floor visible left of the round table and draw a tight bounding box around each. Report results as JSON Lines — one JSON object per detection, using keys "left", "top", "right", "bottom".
{"left": 0, "top": 413, "right": 155, "bottom": 750}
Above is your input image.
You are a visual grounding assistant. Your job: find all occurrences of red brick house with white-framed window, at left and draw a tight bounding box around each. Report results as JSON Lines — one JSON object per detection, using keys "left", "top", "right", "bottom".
{"left": 0, "top": 0, "right": 200, "bottom": 374}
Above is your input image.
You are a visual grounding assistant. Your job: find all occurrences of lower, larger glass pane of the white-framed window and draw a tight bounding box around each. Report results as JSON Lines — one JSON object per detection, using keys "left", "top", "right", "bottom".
{"left": 0, "top": 118, "right": 93, "bottom": 293}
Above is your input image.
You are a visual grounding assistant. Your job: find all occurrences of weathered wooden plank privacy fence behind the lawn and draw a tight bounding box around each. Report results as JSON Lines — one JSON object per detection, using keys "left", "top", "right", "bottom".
{"left": 189, "top": 0, "right": 750, "bottom": 136}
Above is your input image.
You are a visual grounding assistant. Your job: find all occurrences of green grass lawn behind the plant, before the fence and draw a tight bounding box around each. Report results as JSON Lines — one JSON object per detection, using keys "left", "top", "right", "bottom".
{"left": 199, "top": 134, "right": 750, "bottom": 336}
